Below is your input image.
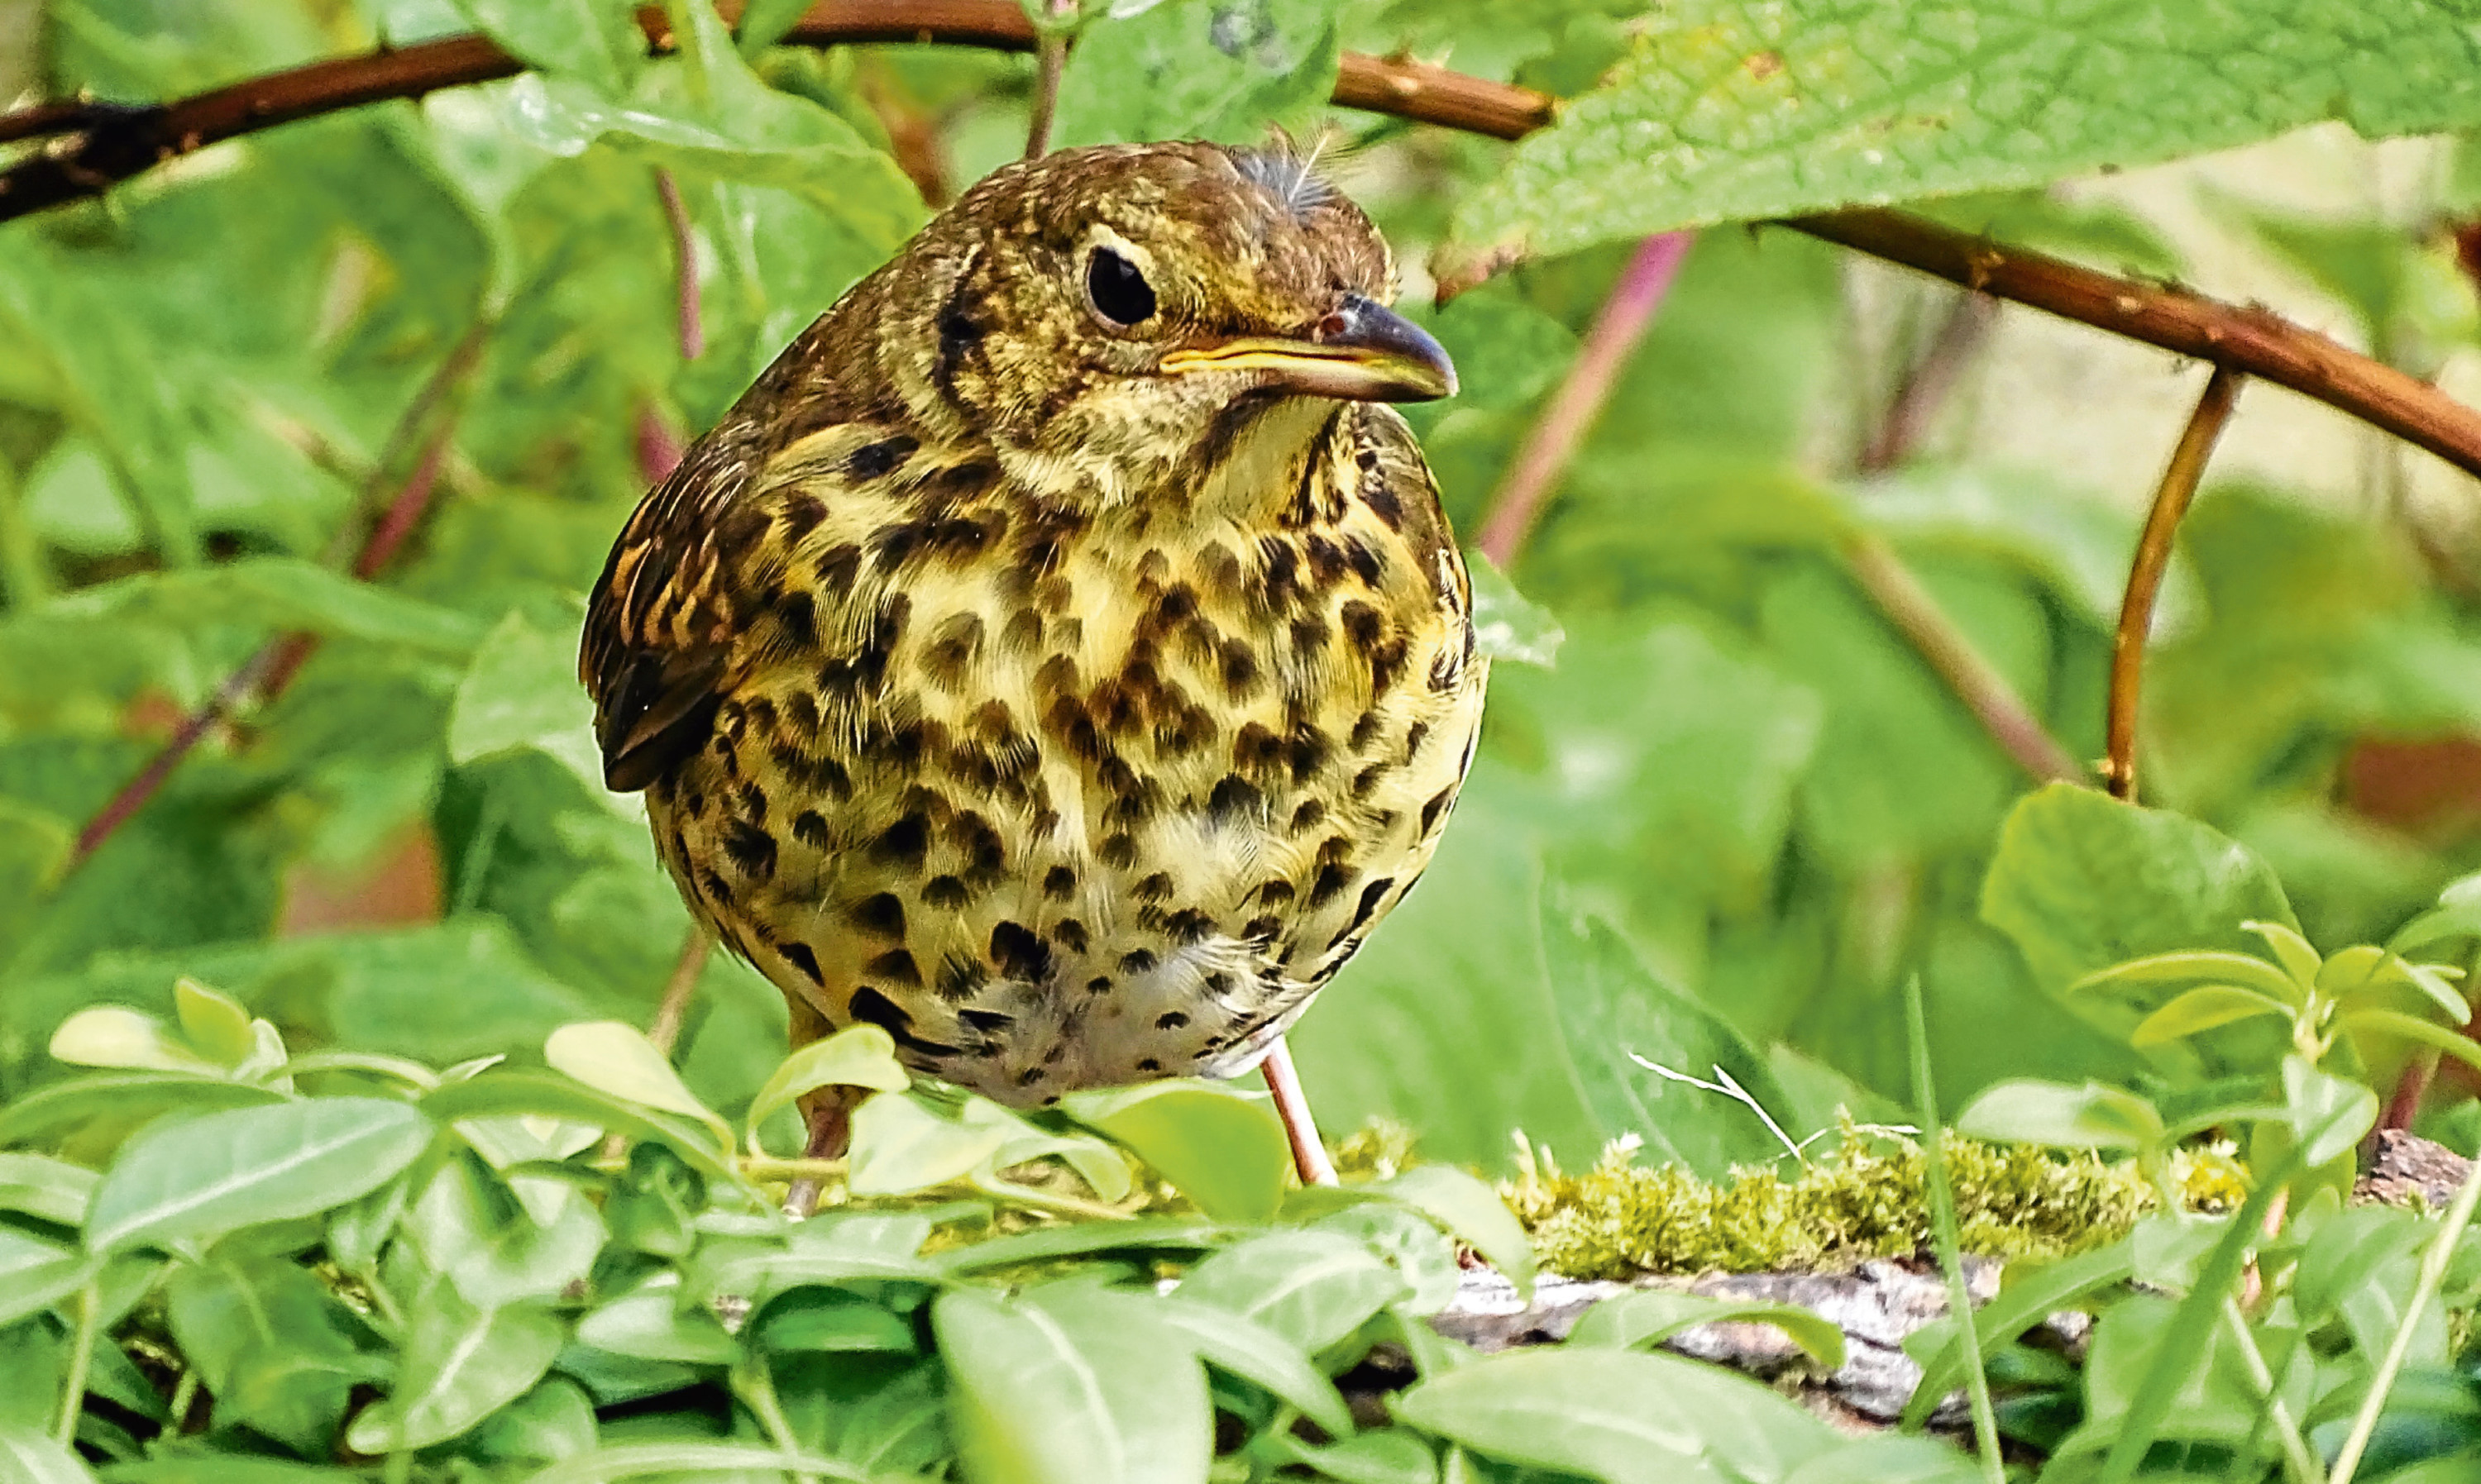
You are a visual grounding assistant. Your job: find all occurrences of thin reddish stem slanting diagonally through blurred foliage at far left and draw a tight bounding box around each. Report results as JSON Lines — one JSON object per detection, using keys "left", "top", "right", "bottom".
{"left": 62, "top": 342, "right": 481, "bottom": 876}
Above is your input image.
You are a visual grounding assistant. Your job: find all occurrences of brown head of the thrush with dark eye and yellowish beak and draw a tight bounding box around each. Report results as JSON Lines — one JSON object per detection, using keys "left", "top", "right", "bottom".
{"left": 866, "top": 144, "right": 1456, "bottom": 503}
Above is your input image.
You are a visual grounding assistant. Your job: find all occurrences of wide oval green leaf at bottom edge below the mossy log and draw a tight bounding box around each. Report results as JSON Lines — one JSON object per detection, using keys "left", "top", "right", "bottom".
{"left": 1394, "top": 1348, "right": 1833, "bottom": 1484}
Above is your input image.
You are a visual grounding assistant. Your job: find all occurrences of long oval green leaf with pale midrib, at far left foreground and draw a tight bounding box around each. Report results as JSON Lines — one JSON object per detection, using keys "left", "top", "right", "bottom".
{"left": 87, "top": 1097, "right": 432, "bottom": 1253}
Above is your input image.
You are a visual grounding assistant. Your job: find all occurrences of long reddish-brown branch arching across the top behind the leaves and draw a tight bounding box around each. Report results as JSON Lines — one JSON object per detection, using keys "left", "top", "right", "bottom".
{"left": 0, "top": 0, "right": 2481, "bottom": 489}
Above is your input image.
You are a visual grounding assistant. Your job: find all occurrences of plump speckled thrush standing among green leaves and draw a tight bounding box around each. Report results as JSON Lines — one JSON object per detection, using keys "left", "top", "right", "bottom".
{"left": 581, "top": 144, "right": 1486, "bottom": 1205}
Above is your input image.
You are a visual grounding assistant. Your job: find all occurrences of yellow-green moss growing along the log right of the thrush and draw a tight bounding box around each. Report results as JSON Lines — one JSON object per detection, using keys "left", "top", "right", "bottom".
{"left": 1501, "top": 1119, "right": 2154, "bottom": 1278}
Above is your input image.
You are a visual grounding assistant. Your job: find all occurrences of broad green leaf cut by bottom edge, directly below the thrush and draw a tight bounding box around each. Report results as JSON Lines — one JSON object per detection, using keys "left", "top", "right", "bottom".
{"left": 930, "top": 1283, "right": 1213, "bottom": 1484}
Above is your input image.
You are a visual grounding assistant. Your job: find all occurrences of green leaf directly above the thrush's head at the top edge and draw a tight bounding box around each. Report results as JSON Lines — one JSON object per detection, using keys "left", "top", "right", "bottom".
{"left": 1052, "top": 0, "right": 1342, "bottom": 146}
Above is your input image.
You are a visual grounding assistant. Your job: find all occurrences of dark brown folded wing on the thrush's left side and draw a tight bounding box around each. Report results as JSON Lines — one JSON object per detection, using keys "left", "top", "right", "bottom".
{"left": 578, "top": 427, "right": 767, "bottom": 792}
